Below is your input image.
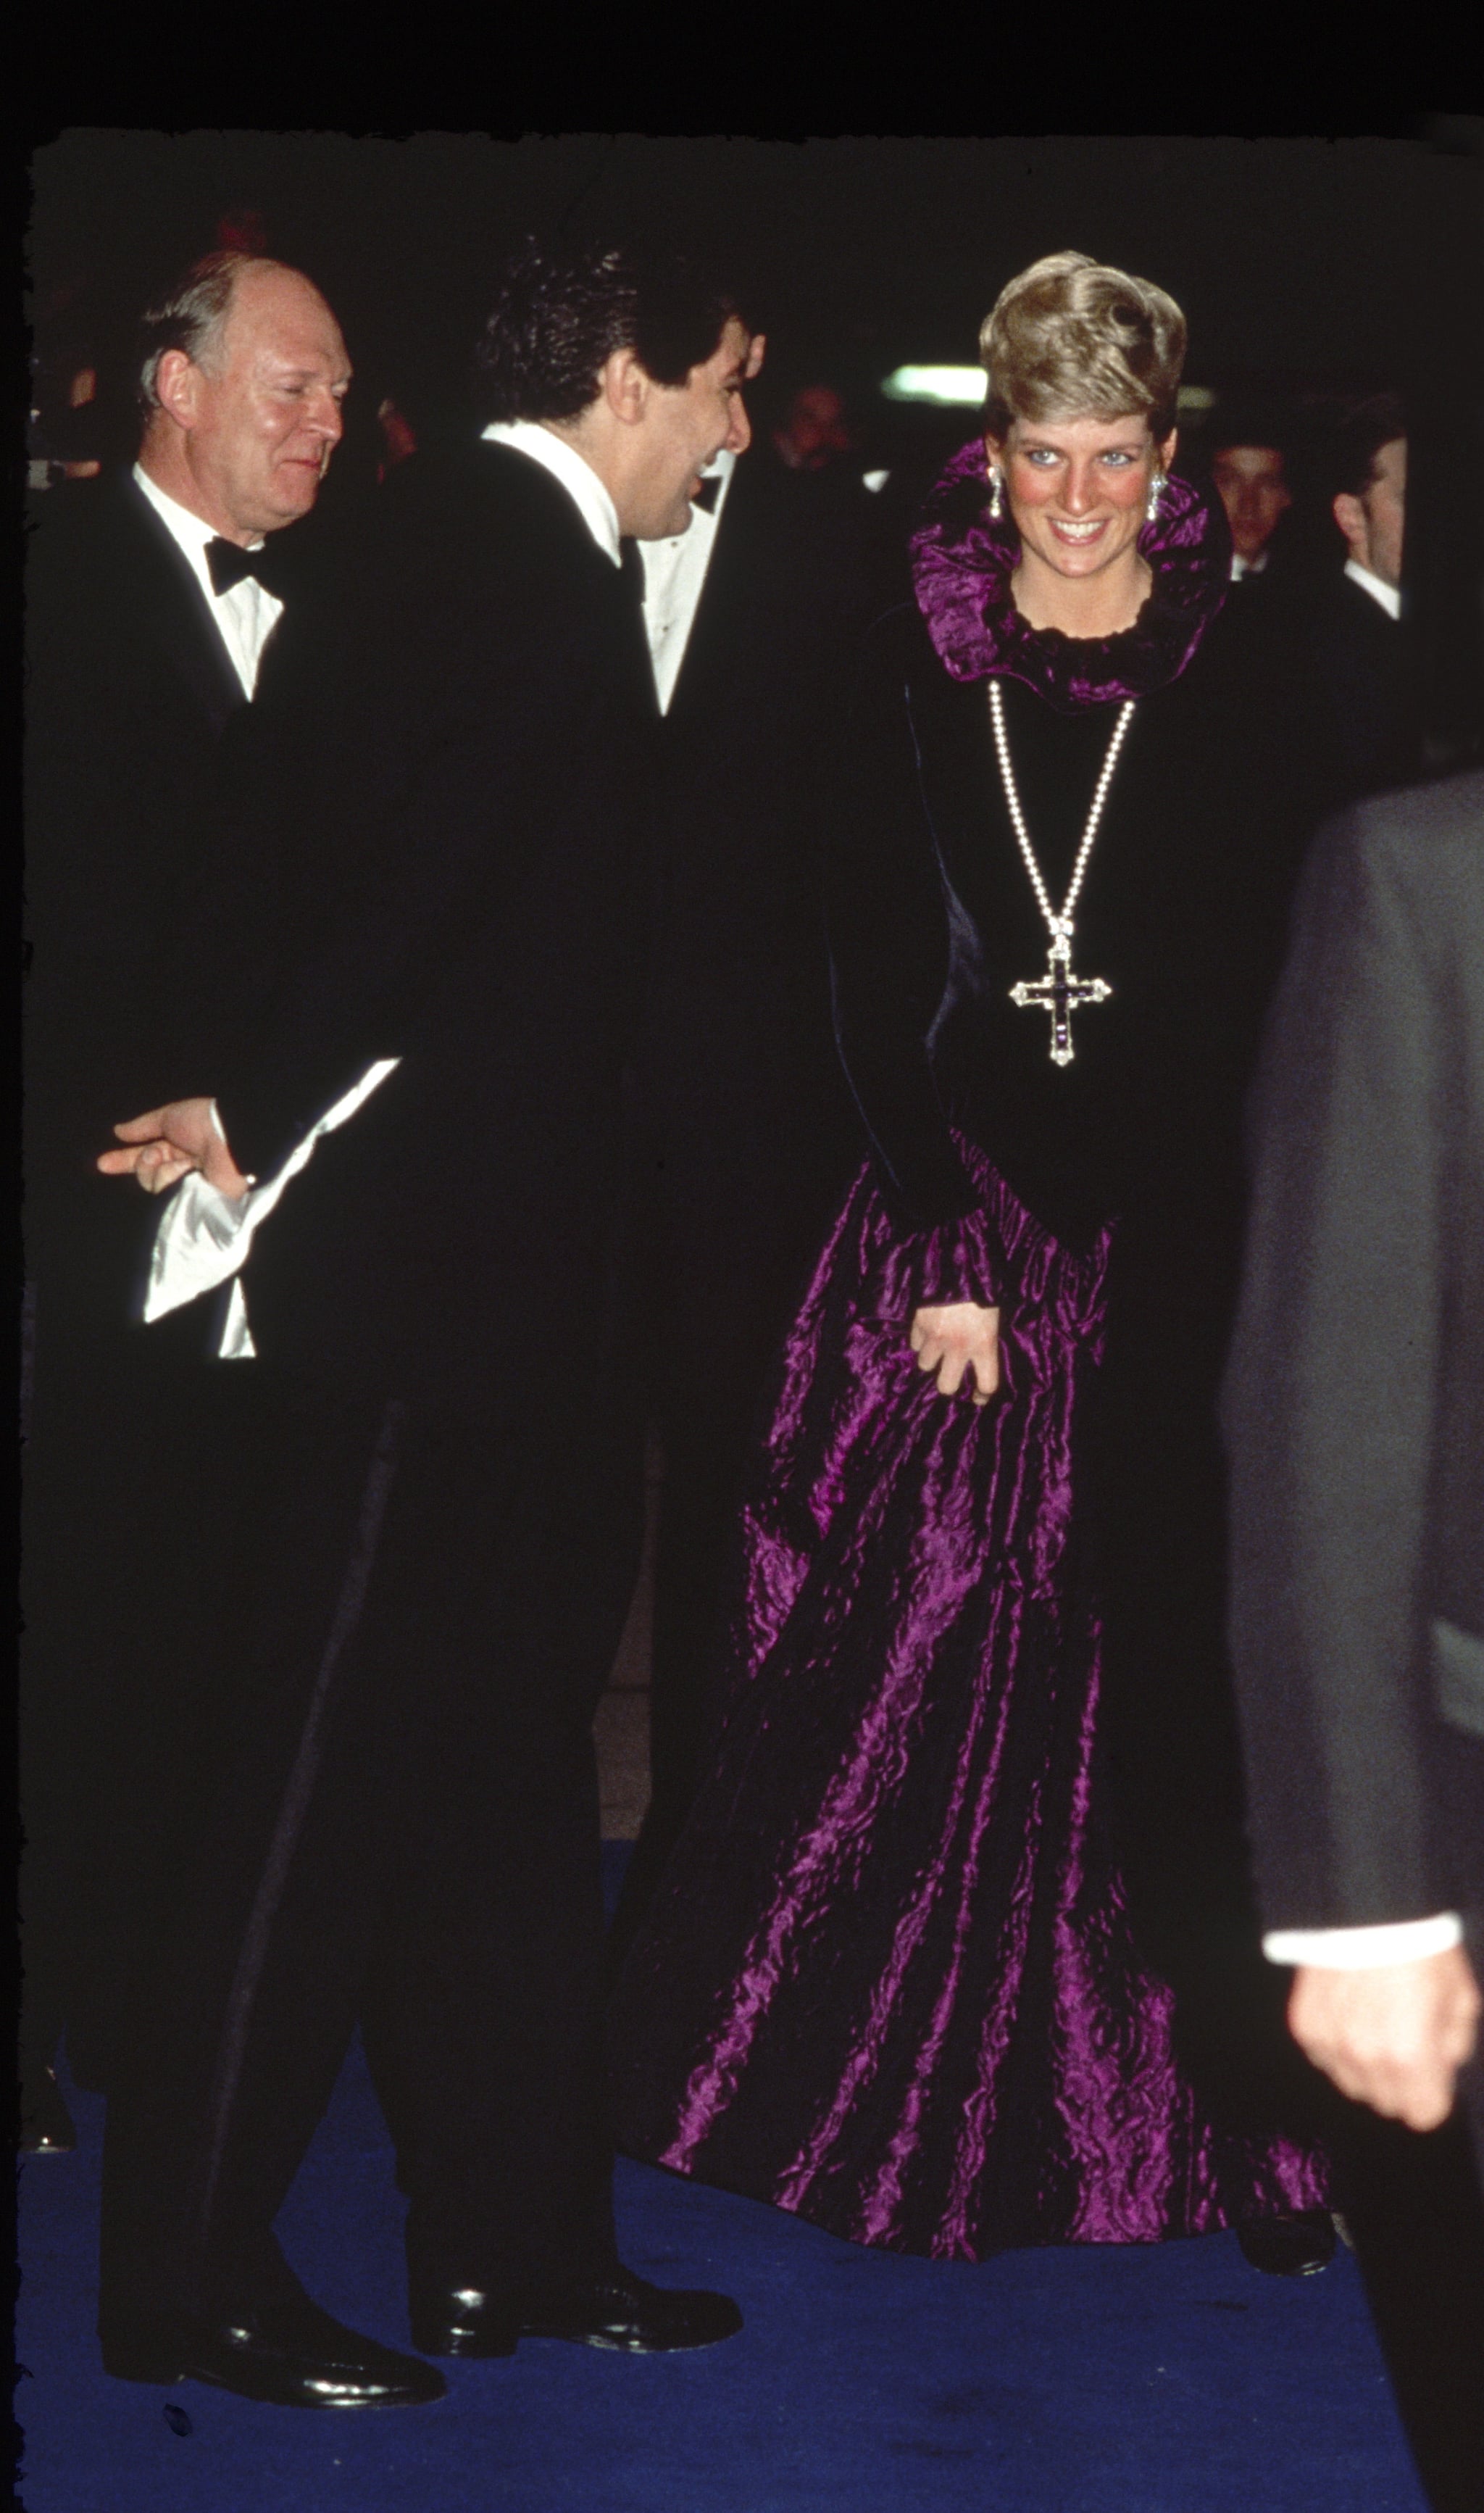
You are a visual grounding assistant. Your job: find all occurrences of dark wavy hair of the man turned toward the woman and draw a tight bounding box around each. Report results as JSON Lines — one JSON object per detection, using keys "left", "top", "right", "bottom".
{"left": 475, "top": 236, "right": 746, "bottom": 422}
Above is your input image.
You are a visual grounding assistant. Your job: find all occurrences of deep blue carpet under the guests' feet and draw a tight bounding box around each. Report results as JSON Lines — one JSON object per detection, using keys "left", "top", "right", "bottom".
{"left": 17, "top": 1839, "right": 1424, "bottom": 2513}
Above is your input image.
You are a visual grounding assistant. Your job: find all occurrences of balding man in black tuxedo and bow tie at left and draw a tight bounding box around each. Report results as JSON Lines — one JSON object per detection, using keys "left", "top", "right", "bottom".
{"left": 22, "top": 252, "right": 349, "bottom": 2153}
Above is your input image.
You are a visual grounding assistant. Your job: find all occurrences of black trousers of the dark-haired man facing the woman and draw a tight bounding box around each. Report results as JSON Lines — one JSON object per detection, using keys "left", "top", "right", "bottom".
{"left": 103, "top": 1362, "right": 643, "bottom": 2314}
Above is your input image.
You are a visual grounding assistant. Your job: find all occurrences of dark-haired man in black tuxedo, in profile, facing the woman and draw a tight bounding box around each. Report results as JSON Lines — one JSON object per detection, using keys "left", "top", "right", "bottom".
{"left": 87, "top": 249, "right": 751, "bottom": 2405}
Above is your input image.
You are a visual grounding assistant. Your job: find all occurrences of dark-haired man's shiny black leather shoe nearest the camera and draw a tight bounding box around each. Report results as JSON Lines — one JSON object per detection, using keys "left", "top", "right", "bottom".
{"left": 98, "top": 2297, "right": 447, "bottom": 2407}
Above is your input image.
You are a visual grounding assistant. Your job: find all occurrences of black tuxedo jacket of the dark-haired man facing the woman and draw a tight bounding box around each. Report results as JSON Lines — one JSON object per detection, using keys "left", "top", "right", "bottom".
{"left": 194, "top": 442, "right": 658, "bottom": 1410}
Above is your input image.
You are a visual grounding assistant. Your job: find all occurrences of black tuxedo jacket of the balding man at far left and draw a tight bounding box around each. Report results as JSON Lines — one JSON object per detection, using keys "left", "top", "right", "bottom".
{"left": 25, "top": 475, "right": 249, "bottom": 1329}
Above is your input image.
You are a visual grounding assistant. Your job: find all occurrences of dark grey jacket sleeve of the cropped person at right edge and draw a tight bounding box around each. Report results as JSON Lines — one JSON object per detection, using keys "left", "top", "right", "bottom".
{"left": 1225, "top": 774, "right": 1484, "bottom": 1927}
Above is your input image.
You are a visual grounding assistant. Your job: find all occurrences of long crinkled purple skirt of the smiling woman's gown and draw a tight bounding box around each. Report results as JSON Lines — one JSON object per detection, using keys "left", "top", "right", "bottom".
{"left": 613, "top": 1146, "right": 1326, "bottom": 2259}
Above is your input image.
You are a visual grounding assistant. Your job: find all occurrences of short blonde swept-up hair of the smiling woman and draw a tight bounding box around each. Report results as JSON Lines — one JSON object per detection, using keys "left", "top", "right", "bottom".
{"left": 979, "top": 254, "right": 1185, "bottom": 440}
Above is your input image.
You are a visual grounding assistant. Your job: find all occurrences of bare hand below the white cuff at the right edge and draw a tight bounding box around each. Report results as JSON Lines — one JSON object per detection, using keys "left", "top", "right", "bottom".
{"left": 1288, "top": 1945, "right": 1484, "bottom": 2129}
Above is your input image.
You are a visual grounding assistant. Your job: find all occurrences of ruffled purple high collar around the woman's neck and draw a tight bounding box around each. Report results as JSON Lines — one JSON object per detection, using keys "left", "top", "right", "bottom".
{"left": 909, "top": 437, "right": 1230, "bottom": 716}
